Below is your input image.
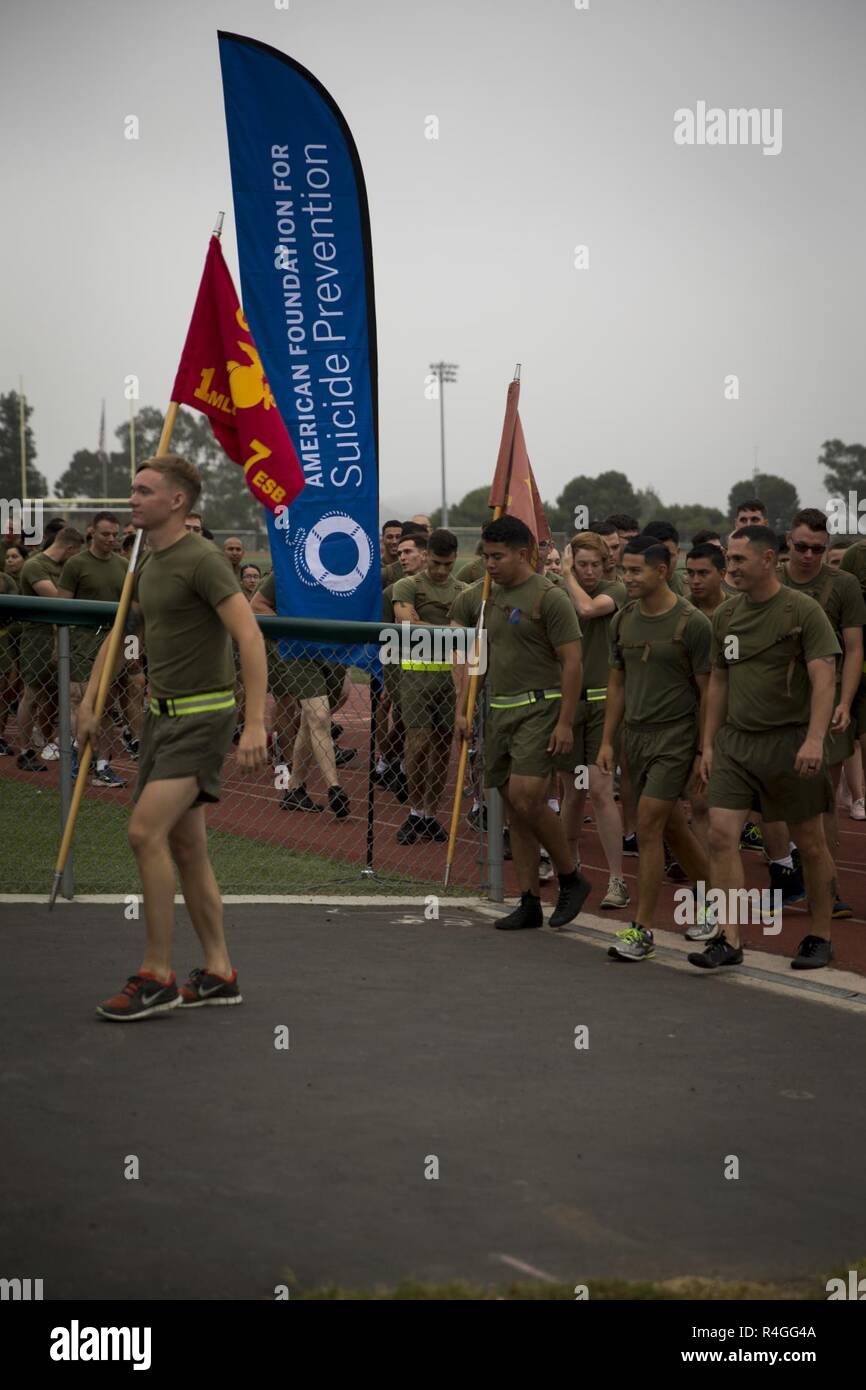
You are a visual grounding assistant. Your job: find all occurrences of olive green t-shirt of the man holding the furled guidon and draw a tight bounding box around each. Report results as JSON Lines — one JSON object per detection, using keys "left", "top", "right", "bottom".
{"left": 450, "top": 574, "right": 581, "bottom": 695}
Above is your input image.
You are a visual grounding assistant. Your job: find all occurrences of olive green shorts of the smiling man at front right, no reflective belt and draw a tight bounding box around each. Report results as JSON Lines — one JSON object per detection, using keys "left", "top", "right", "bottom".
{"left": 706, "top": 724, "right": 833, "bottom": 826}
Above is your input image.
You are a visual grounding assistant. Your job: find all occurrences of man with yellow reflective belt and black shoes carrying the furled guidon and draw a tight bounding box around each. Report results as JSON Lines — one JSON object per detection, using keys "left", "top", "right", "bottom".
{"left": 450, "top": 516, "right": 591, "bottom": 931}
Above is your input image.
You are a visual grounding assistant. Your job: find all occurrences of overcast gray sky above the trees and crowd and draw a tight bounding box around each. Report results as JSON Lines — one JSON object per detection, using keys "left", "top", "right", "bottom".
{"left": 0, "top": 0, "right": 866, "bottom": 514}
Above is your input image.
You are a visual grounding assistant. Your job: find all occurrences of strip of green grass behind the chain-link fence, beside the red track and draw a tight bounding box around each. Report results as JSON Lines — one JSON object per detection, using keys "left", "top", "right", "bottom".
{"left": 0, "top": 778, "right": 466, "bottom": 897}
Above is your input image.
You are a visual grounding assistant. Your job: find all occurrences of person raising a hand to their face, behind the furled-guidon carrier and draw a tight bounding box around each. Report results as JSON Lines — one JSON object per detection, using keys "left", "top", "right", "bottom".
{"left": 563, "top": 531, "right": 630, "bottom": 908}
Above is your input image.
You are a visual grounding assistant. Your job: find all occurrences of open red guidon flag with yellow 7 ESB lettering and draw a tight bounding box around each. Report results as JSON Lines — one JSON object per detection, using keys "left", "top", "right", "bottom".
{"left": 171, "top": 236, "right": 304, "bottom": 512}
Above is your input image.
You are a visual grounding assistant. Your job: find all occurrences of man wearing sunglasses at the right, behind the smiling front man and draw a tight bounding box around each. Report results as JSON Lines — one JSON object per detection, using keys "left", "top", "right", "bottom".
{"left": 765, "top": 507, "right": 866, "bottom": 917}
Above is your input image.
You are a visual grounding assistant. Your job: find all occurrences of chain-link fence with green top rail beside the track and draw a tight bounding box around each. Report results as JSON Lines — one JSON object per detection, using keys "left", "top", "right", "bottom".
{"left": 0, "top": 596, "right": 502, "bottom": 899}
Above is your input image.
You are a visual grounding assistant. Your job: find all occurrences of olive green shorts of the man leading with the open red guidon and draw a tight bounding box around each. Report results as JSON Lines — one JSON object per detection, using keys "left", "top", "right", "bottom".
{"left": 132, "top": 709, "right": 236, "bottom": 806}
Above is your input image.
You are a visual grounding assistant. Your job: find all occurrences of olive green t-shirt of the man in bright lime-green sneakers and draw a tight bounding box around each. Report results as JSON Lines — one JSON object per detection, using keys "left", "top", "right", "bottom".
{"left": 610, "top": 598, "right": 712, "bottom": 726}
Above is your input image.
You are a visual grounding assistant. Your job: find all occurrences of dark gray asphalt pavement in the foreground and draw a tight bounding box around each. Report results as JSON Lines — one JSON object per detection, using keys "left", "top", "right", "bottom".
{"left": 0, "top": 905, "right": 866, "bottom": 1298}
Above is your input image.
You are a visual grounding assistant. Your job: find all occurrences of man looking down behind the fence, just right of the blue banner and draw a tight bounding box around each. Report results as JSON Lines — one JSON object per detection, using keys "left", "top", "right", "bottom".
{"left": 391, "top": 528, "right": 466, "bottom": 845}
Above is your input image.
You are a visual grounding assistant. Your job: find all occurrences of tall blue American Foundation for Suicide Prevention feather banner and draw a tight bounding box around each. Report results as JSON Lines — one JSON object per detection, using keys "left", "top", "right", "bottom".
{"left": 218, "top": 33, "right": 382, "bottom": 666}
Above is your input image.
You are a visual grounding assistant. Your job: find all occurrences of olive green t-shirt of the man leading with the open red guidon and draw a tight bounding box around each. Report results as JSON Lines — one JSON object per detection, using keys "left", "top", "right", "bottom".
{"left": 135, "top": 532, "right": 240, "bottom": 698}
